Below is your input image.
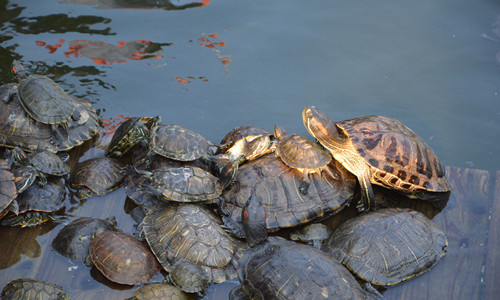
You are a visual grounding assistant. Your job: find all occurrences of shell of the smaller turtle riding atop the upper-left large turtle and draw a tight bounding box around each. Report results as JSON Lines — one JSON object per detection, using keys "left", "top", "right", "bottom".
{"left": 17, "top": 75, "right": 76, "bottom": 124}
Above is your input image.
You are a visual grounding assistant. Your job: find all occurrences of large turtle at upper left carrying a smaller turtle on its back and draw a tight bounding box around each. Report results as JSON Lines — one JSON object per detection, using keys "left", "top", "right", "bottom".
{"left": 0, "top": 83, "right": 101, "bottom": 153}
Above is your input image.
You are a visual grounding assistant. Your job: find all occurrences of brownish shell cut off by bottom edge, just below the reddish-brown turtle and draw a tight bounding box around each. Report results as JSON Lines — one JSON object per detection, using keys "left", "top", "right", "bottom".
{"left": 127, "top": 282, "right": 192, "bottom": 300}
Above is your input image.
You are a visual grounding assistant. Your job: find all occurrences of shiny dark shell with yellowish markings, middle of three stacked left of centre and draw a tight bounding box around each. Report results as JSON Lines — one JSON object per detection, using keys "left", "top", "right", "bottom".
{"left": 151, "top": 167, "right": 222, "bottom": 202}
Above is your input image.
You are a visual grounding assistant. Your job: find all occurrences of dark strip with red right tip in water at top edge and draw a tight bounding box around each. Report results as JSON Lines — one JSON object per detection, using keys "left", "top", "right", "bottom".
{"left": 61, "top": 0, "right": 210, "bottom": 10}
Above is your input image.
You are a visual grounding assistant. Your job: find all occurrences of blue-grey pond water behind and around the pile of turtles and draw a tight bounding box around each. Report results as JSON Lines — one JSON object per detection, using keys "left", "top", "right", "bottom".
{"left": 0, "top": 0, "right": 500, "bottom": 299}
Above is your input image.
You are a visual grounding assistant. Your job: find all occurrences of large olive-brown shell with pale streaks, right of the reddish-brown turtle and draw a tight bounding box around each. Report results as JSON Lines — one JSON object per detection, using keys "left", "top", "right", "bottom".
{"left": 143, "top": 203, "right": 237, "bottom": 283}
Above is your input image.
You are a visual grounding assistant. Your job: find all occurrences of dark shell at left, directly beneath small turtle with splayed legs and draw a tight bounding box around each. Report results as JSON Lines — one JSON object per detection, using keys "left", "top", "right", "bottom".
{"left": 17, "top": 177, "right": 66, "bottom": 213}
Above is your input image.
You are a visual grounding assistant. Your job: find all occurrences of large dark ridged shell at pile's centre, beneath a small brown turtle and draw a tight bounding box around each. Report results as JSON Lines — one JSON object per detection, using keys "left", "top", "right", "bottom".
{"left": 222, "top": 153, "right": 356, "bottom": 229}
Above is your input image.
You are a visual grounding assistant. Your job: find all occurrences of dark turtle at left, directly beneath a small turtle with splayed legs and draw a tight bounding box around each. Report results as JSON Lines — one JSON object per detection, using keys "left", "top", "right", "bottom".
{"left": 1, "top": 177, "right": 66, "bottom": 227}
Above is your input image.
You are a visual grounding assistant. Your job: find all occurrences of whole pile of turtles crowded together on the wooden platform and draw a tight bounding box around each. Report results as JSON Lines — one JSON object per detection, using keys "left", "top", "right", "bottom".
{"left": 0, "top": 63, "right": 450, "bottom": 299}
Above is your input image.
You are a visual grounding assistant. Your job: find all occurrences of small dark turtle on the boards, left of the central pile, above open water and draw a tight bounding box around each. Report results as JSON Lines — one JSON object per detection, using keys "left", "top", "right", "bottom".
{"left": 70, "top": 157, "right": 125, "bottom": 198}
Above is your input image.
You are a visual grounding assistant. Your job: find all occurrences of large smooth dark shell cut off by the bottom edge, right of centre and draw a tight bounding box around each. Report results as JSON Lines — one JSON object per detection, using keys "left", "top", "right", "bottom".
{"left": 238, "top": 237, "right": 370, "bottom": 299}
